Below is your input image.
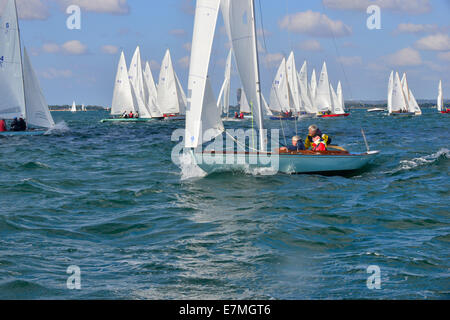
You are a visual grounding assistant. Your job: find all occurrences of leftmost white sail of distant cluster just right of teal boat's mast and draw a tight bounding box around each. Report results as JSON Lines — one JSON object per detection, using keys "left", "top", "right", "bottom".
{"left": 270, "top": 58, "right": 291, "bottom": 112}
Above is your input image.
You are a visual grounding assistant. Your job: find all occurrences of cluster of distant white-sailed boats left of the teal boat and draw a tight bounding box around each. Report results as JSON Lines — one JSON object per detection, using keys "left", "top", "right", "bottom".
{"left": 102, "top": 47, "right": 187, "bottom": 122}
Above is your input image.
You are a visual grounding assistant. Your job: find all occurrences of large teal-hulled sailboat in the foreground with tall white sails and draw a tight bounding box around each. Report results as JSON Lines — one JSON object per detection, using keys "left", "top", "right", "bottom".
{"left": 185, "top": 0, "right": 379, "bottom": 173}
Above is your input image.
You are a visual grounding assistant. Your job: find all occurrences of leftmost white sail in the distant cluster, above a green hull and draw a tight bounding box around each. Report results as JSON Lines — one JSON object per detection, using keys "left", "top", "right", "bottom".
{"left": 111, "top": 52, "right": 136, "bottom": 116}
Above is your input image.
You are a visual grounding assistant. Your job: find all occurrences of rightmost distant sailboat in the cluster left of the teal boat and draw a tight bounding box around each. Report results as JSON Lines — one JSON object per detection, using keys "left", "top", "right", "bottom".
{"left": 157, "top": 50, "right": 187, "bottom": 120}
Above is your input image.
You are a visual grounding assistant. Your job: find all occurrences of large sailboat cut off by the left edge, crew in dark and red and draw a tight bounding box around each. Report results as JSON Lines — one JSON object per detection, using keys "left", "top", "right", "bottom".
{"left": 0, "top": 0, "right": 55, "bottom": 135}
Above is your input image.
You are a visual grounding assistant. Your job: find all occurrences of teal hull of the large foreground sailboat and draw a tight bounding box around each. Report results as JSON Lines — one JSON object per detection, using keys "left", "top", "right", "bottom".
{"left": 192, "top": 151, "right": 379, "bottom": 174}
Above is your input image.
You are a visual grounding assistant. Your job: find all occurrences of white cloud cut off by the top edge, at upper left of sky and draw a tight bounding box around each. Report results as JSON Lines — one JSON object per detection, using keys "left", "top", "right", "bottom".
{"left": 55, "top": 0, "right": 130, "bottom": 14}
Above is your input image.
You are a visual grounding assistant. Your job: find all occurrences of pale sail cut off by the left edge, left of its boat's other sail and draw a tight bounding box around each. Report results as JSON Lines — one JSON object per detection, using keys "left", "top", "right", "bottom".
{"left": 0, "top": 0, "right": 26, "bottom": 119}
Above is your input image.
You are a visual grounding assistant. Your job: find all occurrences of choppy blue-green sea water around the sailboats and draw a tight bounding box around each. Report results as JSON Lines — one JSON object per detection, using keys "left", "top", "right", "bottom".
{"left": 0, "top": 110, "right": 450, "bottom": 299}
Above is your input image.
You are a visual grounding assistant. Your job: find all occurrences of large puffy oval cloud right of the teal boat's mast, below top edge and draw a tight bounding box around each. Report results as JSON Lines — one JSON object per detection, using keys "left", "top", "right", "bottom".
{"left": 279, "top": 10, "right": 352, "bottom": 37}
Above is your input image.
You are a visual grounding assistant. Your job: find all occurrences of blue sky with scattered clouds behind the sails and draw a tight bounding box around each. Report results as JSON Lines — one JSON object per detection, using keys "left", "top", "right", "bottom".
{"left": 0, "top": 0, "right": 450, "bottom": 106}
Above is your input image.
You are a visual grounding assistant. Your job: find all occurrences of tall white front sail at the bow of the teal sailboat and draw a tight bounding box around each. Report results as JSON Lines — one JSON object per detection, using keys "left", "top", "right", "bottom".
{"left": 185, "top": 0, "right": 224, "bottom": 148}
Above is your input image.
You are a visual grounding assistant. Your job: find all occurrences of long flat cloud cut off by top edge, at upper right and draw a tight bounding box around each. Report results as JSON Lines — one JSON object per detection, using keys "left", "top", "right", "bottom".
{"left": 322, "top": 0, "right": 432, "bottom": 14}
